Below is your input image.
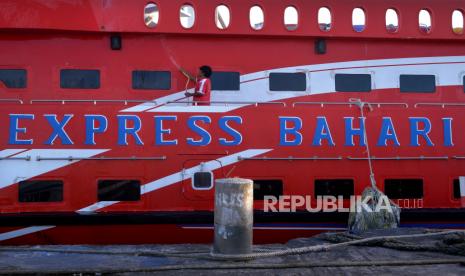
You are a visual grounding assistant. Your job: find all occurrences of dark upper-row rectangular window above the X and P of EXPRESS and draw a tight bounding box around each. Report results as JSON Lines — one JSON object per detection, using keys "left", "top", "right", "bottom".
{"left": 60, "top": 69, "right": 100, "bottom": 89}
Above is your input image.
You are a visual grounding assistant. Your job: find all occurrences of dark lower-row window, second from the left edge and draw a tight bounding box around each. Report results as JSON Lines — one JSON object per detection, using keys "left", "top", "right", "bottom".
{"left": 98, "top": 179, "right": 140, "bottom": 201}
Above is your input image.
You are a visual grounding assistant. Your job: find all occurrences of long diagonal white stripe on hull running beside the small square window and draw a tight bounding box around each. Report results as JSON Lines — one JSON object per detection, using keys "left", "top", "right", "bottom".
{"left": 76, "top": 149, "right": 271, "bottom": 214}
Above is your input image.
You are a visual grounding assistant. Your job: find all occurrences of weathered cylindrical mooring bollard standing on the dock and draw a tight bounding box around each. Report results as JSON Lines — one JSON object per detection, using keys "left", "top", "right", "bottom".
{"left": 213, "top": 178, "right": 253, "bottom": 254}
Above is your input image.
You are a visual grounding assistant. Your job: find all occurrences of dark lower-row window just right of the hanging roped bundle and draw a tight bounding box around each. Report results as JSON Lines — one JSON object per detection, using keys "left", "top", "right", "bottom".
{"left": 384, "top": 179, "right": 423, "bottom": 199}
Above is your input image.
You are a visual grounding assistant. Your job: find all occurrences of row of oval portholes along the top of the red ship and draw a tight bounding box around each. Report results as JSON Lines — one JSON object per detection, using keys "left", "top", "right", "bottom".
{"left": 144, "top": 3, "right": 464, "bottom": 34}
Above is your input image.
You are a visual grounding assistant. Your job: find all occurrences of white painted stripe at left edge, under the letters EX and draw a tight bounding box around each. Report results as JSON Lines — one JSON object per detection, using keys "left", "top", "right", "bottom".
{"left": 0, "top": 149, "right": 108, "bottom": 189}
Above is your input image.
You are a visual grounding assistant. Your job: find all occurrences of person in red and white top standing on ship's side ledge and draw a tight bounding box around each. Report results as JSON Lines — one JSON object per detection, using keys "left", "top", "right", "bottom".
{"left": 179, "top": 65, "right": 213, "bottom": 105}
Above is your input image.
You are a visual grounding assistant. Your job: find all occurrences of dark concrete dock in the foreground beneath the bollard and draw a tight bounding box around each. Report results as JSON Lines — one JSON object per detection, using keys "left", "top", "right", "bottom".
{"left": 0, "top": 228, "right": 465, "bottom": 275}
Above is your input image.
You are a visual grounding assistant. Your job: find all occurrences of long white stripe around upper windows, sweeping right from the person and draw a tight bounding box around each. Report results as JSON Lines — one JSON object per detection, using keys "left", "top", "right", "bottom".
{"left": 123, "top": 56, "right": 465, "bottom": 113}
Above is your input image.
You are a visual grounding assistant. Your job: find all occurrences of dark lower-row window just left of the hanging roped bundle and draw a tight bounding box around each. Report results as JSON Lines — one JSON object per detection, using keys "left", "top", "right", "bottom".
{"left": 315, "top": 179, "right": 354, "bottom": 198}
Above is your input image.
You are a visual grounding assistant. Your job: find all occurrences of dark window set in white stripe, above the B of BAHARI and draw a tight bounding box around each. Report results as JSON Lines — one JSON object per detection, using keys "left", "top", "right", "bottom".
{"left": 270, "top": 73, "right": 307, "bottom": 91}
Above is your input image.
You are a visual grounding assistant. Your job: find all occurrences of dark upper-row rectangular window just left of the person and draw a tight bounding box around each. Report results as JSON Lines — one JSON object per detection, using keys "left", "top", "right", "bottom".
{"left": 132, "top": 71, "right": 171, "bottom": 90}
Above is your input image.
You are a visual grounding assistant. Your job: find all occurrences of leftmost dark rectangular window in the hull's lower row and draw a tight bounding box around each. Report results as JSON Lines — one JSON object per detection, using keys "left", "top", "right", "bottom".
{"left": 19, "top": 180, "right": 63, "bottom": 202}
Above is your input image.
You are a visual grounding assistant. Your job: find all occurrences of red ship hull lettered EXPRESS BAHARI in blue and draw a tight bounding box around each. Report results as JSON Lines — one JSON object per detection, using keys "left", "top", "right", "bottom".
{"left": 0, "top": 0, "right": 465, "bottom": 244}
